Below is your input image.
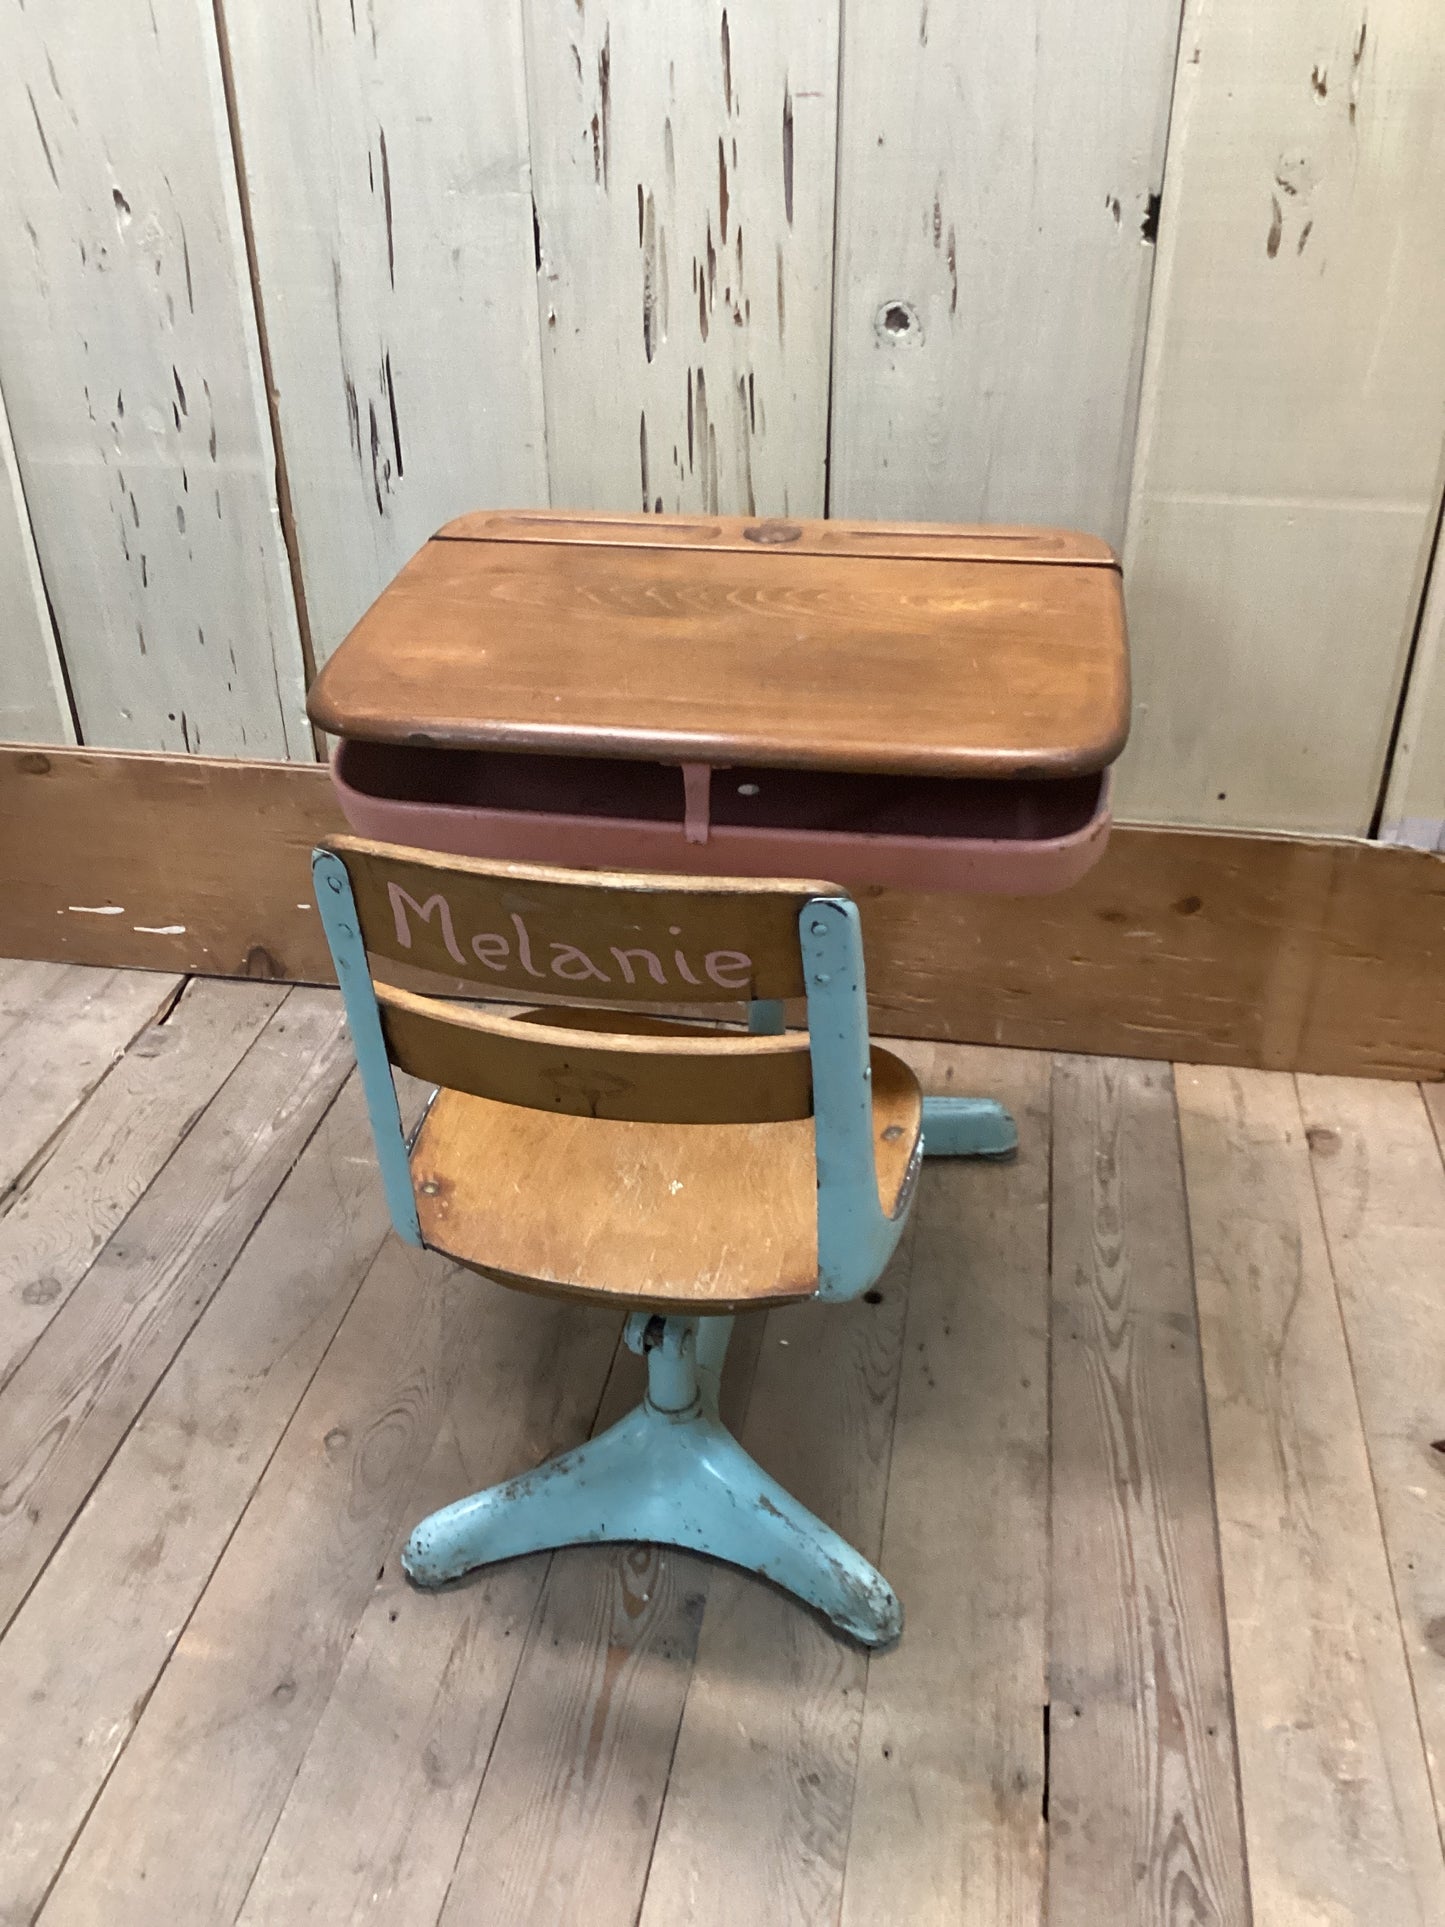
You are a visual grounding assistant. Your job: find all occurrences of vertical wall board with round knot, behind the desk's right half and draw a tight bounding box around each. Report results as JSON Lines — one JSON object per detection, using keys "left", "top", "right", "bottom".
{"left": 830, "top": 0, "right": 1179, "bottom": 543}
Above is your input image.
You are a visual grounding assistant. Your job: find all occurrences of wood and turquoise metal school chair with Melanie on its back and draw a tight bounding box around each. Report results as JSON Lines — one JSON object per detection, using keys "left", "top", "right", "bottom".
{"left": 312, "top": 836, "right": 1015, "bottom": 1646}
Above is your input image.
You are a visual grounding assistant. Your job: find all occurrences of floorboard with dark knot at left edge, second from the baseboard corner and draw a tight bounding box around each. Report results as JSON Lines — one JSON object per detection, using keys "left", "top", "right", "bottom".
{"left": 0, "top": 979, "right": 285, "bottom": 1384}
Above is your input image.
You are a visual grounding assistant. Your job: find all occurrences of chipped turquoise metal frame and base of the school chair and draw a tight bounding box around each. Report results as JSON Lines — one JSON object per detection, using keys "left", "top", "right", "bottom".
{"left": 312, "top": 850, "right": 1017, "bottom": 1646}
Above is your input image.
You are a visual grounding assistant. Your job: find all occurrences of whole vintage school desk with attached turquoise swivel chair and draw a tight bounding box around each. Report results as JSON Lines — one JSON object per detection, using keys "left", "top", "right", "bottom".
{"left": 310, "top": 513, "right": 1129, "bottom": 1644}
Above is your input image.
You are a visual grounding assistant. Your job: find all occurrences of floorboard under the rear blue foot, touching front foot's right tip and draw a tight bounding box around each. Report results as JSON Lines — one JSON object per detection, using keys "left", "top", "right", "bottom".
{"left": 840, "top": 1044, "right": 1050, "bottom": 1927}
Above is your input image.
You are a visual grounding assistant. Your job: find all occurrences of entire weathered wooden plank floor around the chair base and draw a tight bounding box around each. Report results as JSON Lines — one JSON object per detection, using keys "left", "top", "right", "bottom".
{"left": 0, "top": 964, "right": 1445, "bottom": 1927}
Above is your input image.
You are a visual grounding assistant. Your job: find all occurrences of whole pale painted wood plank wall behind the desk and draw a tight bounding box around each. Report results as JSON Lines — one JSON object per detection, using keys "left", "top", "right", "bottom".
{"left": 0, "top": 0, "right": 1445, "bottom": 842}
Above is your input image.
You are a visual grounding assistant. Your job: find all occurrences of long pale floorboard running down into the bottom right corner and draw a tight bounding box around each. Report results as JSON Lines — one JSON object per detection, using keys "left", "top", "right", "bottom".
{"left": 1177, "top": 1068, "right": 1445, "bottom": 1927}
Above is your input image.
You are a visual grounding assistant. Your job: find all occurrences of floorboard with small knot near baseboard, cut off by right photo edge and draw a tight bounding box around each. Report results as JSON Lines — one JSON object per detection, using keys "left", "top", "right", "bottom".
{"left": 1299, "top": 1077, "right": 1445, "bottom": 1836}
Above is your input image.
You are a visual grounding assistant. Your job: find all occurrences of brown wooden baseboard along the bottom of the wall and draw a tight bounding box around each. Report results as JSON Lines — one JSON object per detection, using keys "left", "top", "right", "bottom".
{"left": 0, "top": 748, "right": 1445, "bottom": 1081}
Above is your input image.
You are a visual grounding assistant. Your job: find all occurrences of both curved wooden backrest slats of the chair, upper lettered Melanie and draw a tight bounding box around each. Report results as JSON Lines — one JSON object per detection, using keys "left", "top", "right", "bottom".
{"left": 322, "top": 836, "right": 840, "bottom": 1123}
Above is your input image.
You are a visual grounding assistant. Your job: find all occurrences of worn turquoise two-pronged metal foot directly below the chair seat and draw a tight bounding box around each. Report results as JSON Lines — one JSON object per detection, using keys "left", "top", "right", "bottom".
{"left": 401, "top": 1399, "right": 904, "bottom": 1646}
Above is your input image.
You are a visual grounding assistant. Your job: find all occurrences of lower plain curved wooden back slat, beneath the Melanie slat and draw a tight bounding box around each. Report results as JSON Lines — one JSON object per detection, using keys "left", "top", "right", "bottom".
{"left": 376, "top": 985, "right": 813, "bottom": 1123}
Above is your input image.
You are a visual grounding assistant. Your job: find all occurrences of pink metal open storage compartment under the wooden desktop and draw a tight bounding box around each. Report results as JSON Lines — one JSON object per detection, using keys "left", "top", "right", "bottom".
{"left": 331, "top": 742, "right": 1110, "bottom": 896}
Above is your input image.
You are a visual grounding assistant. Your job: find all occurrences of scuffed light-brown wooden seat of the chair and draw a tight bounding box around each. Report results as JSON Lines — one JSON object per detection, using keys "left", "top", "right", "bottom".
{"left": 412, "top": 1046, "right": 923, "bottom": 1312}
